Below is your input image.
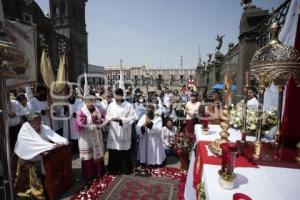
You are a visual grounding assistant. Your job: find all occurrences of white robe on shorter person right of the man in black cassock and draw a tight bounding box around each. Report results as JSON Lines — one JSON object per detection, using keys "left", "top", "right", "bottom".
{"left": 136, "top": 115, "right": 166, "bottom": 165}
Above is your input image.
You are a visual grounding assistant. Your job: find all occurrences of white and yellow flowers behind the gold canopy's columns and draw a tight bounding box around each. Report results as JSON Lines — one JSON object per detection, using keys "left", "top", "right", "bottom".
{"left": 229, "top": 102, "right": 277, "bottom": 131}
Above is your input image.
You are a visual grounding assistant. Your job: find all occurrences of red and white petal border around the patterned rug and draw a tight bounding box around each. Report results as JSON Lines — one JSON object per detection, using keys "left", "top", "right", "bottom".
{"left": 70, "top": 167, "right": 186, "bottom": 200}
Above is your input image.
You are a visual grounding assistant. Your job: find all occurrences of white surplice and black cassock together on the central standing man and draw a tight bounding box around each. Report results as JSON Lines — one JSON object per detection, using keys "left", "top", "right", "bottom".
{"left": 106, "top": 101, "right": 138, "bottom": 174}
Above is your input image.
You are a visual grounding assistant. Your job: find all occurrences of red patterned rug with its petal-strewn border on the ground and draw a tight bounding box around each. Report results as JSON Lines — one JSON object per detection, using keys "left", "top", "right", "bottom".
{"left": 71, "top": 167, "right": 186, "bottom": 200}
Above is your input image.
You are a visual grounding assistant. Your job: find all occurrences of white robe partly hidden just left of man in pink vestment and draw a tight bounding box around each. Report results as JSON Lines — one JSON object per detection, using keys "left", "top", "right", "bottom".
{"left": 62, "top": 98, "right": 82, "bottom": 140}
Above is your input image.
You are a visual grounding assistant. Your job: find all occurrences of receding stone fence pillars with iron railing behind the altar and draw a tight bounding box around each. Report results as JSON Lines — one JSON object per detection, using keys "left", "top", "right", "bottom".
{"left": 196, "top": 0, "right": 291, "bottom": 95}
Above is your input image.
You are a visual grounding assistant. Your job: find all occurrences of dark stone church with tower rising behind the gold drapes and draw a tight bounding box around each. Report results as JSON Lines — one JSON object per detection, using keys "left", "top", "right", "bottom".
{"left": 3, "top": 0, "right": 88, "bottom": 82}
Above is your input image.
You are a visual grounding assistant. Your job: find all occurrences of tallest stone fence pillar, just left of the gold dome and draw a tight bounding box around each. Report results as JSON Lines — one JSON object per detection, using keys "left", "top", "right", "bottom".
{"left": 237, "top": 6, "right": 269, "bottom": 95}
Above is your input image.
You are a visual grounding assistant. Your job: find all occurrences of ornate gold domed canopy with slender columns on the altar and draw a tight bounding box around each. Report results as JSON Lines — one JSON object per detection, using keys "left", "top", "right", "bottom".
{"left": 250, "top": 23, "right": 300, "bottom": 146}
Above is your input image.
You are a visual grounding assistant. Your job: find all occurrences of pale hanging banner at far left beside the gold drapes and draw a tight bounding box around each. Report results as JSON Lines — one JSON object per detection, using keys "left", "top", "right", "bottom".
{"left": 5, "top": 19, "right": 37, "bottom": 87}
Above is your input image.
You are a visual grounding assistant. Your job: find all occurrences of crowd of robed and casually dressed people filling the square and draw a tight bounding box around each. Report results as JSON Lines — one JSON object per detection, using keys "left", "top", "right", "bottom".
{"left": 7, "top": 82, "right": 258, "bottom": 197}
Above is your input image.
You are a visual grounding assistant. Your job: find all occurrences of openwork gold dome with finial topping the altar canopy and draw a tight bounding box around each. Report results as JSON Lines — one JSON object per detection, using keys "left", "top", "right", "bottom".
{"left": 250, "top": 23, "right": 300, "bottom": 86}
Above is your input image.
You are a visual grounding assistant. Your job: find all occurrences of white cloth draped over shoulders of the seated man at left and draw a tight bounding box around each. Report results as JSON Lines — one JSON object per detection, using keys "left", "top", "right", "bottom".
{"left": 14, "top": 122, "right": 68, "bottom": 160}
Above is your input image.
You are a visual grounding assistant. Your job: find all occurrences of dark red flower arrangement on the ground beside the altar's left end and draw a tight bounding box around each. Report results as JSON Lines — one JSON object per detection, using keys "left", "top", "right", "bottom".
{"left": 174, "top": 128, "right": 196, "bottom": 155}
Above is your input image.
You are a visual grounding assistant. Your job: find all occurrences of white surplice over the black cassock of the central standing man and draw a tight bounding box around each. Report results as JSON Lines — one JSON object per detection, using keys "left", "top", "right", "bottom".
{"left": 106, "top": 101, "right": 138, "bottom": 150}
